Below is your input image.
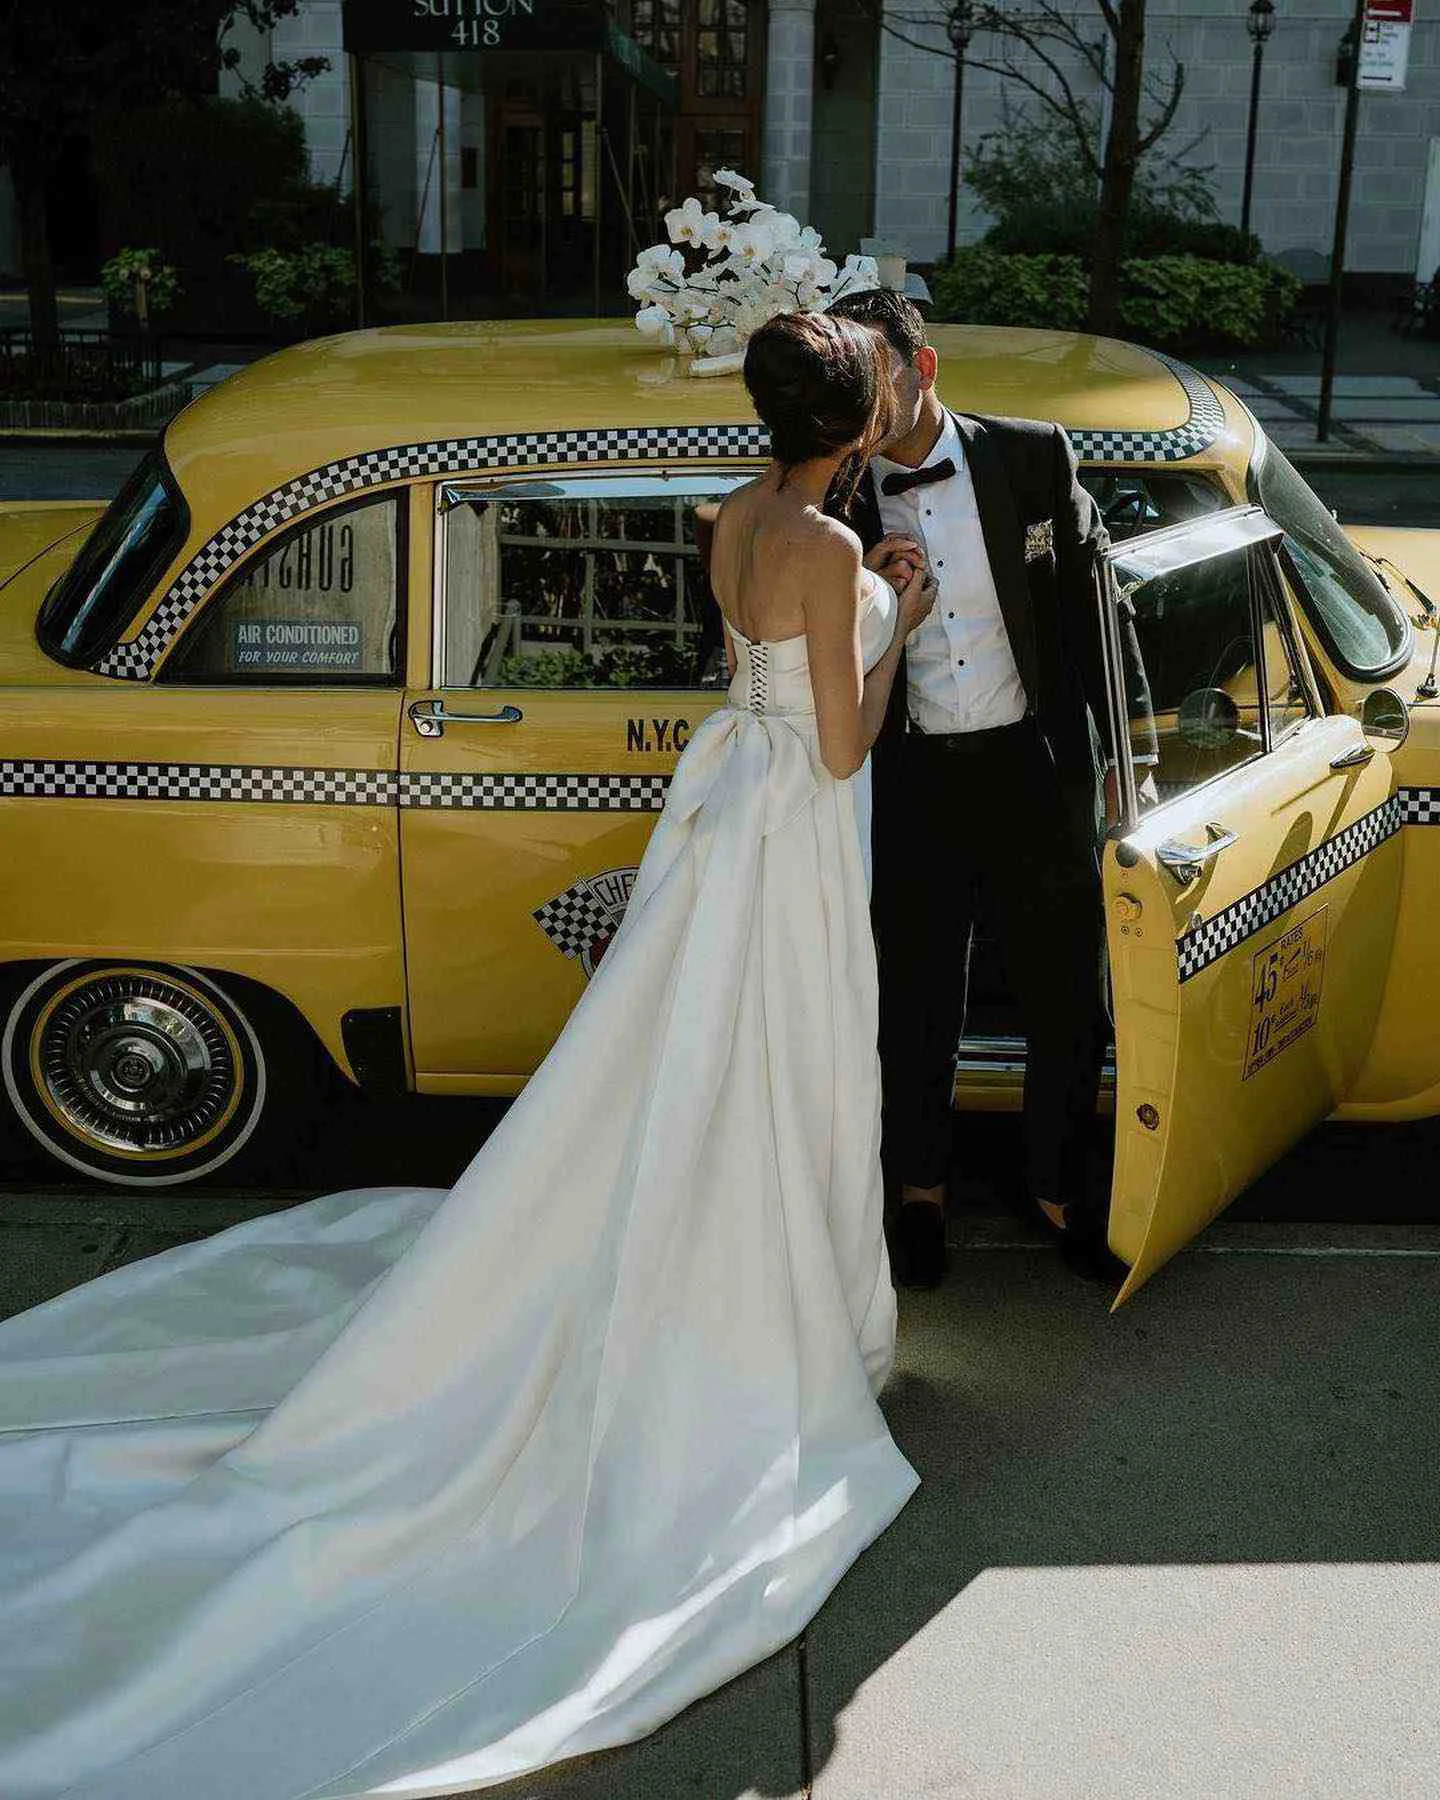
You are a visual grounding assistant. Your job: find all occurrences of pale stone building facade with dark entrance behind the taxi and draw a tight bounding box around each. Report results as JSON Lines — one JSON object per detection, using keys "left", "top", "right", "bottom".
{"left": 0, "top": 0, "right": 1440, "bottom": 306}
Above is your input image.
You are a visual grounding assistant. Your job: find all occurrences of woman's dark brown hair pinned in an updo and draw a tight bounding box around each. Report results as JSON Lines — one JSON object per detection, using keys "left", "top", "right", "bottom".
{"left": 745, "top": 313, "right": 895, "bottom": 504}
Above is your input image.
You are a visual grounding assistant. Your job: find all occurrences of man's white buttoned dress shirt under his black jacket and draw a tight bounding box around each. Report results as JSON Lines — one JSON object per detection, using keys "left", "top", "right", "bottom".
{"left": 869, "top": 412, "right": 1026, "bottom": 733}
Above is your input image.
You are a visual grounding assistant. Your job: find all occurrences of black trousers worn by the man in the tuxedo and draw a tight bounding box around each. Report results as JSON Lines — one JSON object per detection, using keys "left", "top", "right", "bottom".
{"left": 875, "top": 718, "right": 1107, "bottom": 1206}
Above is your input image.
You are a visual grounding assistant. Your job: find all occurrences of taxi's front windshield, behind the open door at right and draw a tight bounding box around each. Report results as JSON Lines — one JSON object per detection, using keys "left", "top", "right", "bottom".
{"left": 1251, "top": 445, "right": 1409, "bottom": 679}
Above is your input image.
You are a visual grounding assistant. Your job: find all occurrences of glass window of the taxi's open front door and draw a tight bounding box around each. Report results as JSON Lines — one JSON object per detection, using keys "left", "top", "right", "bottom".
{"left": 1118, "top": 545, "right": 1314, "bottom": 805}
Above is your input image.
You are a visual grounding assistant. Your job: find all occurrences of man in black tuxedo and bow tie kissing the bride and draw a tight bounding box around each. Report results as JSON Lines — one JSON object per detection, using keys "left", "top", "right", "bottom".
{"left": 832, "top": 288, "right": 1143, "bottom": 1287}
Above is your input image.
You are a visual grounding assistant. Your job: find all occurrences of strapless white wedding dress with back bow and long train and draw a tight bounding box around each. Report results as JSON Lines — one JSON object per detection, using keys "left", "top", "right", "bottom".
{"left": 0, "top": 580, "right": 916, "bottom": 1800}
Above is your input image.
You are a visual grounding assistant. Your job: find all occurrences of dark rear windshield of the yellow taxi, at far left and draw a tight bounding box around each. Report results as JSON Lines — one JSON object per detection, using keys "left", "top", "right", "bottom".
{"left": 36, "top": 450, "right": 189, "bottom": 664}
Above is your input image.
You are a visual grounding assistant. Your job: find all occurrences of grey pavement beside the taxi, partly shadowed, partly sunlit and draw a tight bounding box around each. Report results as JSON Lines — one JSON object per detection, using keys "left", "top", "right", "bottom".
{"left": 11, "top": 1188, "right": 1440, "bottom": 1800}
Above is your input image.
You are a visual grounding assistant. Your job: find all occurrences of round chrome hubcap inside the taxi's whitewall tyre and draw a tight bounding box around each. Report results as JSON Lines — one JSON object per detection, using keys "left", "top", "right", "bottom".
{"left": 38, "top": 974, "right": 241, "bottom": 1152}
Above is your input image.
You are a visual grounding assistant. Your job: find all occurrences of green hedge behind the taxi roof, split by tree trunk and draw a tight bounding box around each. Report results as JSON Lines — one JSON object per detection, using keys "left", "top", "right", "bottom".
{"left": 931, "top": 245, "right": 1300, "bottom": 349}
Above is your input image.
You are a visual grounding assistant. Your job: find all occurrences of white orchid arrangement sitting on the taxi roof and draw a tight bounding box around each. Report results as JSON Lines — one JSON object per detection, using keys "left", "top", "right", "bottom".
{"left": 626, "top": 169, "right": 880, "bottom": 362}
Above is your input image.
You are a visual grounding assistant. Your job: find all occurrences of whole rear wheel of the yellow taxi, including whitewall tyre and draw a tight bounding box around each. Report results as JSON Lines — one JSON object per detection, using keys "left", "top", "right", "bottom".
{"left": 0, "top": 961, "right": 270, "bottom": 1188}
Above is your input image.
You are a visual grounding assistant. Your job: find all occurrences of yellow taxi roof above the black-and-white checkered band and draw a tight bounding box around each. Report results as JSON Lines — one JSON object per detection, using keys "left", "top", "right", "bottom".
{"left": 166, "top": 319, "right": 1249, "bottom": 524}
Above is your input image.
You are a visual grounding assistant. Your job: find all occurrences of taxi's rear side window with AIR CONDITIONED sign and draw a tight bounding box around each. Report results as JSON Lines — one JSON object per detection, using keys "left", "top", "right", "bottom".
{"left": 160, "top": 493, "right": 405, "bottom": 686}
